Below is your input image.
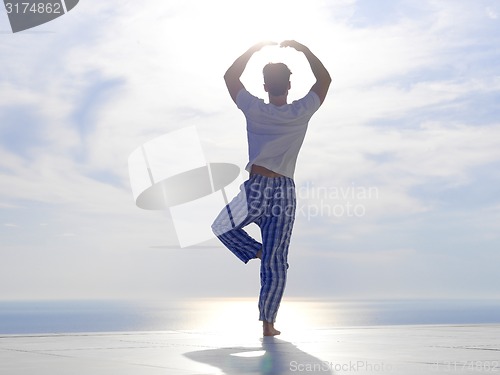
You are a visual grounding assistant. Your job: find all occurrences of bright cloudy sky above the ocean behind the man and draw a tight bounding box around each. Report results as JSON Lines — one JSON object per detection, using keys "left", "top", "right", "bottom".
{"left": 0, "top": 0, "right": 500, "bottom": 300}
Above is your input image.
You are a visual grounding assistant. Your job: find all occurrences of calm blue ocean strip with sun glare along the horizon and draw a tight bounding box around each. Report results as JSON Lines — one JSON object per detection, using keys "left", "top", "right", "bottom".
{"left": 0, "top": 298, "right": 500, "bottom": 335}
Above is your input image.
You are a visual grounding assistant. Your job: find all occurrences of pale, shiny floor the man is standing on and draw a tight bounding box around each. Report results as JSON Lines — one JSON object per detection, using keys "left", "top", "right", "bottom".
{"left": 0, "top": 325, "right": 500, "bottom": 375}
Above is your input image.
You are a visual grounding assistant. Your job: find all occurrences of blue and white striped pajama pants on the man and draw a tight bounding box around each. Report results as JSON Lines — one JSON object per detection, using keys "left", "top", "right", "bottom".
{"left": 212, "top": 174, "right": 296, "bottom": 323}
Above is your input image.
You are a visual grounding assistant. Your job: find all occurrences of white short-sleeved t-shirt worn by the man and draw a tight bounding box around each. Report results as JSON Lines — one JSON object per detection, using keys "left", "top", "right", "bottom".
{"left": 236, "top": 89, "right": 321, "bottom": 178}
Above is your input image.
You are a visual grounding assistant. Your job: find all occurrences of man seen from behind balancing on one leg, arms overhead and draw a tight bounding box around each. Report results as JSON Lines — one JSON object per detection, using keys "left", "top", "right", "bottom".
{"left": 212, "top": 40, "right": 331, "bottom": 336}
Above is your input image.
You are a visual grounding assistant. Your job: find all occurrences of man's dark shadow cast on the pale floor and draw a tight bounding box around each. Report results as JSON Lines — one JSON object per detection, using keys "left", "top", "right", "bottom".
{"left": 184, "top": 337, "right": 333, "bottom": 375}
